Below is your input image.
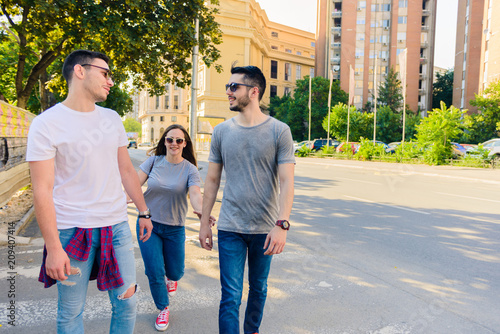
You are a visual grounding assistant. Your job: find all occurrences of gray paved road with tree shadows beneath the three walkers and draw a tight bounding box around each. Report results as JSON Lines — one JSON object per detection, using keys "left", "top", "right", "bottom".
{"left": 0, "top": 149, "right": 500, "bottom": 334}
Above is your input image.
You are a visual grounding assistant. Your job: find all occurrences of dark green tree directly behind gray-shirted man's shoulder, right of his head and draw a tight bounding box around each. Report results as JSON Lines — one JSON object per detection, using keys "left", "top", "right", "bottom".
{"left": 269, "top": 76, "right": 348, "bottom": 141}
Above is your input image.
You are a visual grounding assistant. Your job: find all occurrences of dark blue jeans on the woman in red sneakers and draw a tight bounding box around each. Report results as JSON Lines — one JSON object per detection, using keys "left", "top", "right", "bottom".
{"left": 137, "top": 222, "right": 186, "bottom": 310}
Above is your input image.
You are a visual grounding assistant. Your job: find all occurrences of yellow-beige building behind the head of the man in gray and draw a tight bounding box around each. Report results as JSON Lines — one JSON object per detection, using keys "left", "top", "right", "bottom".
{"left": 139, "top": 0, "right": 315, "bottom": 149}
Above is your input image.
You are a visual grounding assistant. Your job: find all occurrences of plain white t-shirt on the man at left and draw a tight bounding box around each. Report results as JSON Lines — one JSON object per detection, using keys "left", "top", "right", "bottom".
{"left": 26, "top": 103, "right": 128, "bottom": 229}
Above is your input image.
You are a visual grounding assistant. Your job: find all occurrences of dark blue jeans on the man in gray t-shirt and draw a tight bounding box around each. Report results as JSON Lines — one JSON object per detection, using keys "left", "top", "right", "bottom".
{"left": 218, "top": 230, "right": 272, "bottom": 334}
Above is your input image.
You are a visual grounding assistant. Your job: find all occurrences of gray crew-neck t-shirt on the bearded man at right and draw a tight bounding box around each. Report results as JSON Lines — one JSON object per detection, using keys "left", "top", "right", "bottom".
{"left": 208, "top": 117, "right": 295, "bottom": 234}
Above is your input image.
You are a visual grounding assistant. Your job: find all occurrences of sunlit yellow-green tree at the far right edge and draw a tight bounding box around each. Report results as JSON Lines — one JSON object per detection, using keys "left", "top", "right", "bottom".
{"left": 470, "top": 79, "right": 500, "bottom": 142}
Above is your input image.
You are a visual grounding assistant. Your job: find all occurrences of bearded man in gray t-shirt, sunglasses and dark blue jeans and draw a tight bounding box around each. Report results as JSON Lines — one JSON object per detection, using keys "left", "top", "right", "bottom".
{"left": 200, "top": 66, "right": 295, "bottom": 334}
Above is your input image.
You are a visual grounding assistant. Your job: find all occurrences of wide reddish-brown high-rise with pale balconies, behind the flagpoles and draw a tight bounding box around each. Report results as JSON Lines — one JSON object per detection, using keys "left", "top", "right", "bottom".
{"left": 316, "top": 0, "right": 436, "bottom": 112}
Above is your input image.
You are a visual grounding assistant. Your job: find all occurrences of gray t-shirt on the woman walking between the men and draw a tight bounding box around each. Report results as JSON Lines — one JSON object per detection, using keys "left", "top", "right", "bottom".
{"left": 140, "top": 155, "right": 201, "bottom": 226}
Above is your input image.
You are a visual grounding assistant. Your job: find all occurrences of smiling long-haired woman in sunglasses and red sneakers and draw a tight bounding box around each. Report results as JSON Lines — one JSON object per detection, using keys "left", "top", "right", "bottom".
{"left": 137, "top": 124, "right": 214, "bottom": 331}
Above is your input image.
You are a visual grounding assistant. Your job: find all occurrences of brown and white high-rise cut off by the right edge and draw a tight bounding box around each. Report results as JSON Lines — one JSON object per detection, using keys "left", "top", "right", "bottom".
{"left": 453, "top": 0, "right": 500, "bottom": 113}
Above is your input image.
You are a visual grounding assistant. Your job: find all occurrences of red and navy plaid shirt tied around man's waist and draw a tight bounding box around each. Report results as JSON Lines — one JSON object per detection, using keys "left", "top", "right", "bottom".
{"left": 38, "top": 226, "right": 123, "bottom": 291}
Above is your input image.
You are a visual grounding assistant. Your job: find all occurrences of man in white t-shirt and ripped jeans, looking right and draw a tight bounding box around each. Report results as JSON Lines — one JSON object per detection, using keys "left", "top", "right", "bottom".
{"left": 26, "top": 50, "right": 153, "bottom": 334}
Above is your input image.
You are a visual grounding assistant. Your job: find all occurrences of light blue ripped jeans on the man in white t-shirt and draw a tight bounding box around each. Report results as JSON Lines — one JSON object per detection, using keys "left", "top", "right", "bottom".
{"left": 57, "top": 222, "right": 137, "bottom": 334}
